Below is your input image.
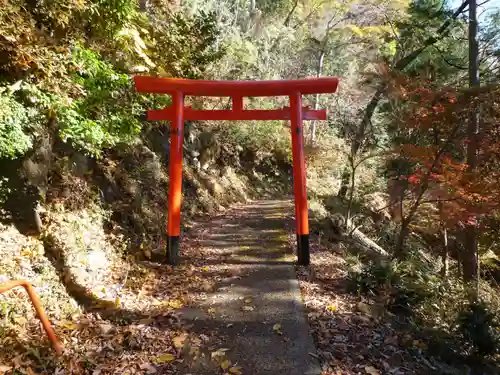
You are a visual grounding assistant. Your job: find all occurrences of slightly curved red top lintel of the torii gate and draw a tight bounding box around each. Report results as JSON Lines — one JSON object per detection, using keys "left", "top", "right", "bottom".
{"left": 134, "top": 76, "right": 339, "bottom": 97}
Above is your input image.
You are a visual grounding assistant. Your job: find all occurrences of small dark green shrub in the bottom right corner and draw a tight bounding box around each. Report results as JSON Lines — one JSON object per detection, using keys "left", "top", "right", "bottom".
{"left": 457, "top": 302, "right": 500, "bottom": 356}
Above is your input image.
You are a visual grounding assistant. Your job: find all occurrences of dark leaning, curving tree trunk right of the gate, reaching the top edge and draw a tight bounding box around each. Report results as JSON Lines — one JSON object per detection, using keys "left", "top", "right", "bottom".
{"left": 338, "top": 0, "right": 469, "bottom": 198}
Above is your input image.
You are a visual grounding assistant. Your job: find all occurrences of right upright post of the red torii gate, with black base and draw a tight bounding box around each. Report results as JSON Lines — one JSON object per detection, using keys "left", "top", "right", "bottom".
{"left": 290, "top": 93, "right": 309, "bottom": 266}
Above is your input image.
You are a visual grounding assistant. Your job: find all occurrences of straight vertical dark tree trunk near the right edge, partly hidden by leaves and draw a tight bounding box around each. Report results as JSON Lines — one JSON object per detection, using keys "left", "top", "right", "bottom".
{"left": 463, "top": 0, "right": 480, "bottom": 282}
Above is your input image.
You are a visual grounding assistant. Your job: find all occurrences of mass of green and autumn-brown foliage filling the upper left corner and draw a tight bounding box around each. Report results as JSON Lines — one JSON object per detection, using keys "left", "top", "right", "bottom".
{"left": 0, "top": 0, "right": 224, "bottom": 158}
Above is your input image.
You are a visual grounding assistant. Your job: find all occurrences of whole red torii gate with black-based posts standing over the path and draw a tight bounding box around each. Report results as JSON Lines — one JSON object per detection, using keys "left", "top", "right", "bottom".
{"left": 134, "top": 76, "right": 338, "bottom": 265}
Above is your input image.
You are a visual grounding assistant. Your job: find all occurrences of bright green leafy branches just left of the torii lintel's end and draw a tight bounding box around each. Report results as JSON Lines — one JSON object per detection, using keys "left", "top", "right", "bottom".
{"left": 58, "top": 46, "right": 142, "bottom": 156}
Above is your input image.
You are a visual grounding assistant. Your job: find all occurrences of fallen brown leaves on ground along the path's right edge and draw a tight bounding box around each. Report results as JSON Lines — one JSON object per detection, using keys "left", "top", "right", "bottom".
{"left": 289, "top": 231, "right": 492, "bottom": 375}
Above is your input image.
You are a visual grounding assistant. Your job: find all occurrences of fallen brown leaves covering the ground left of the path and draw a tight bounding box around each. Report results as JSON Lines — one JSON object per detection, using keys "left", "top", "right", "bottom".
{"left": 0, "top": 217, "right": 232, "bottom": 375}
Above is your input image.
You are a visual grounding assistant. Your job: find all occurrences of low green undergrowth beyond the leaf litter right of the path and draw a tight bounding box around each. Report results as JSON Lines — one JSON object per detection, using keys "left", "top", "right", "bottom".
{"left": 346, "top": 250, "right": 500, "bottom": 357}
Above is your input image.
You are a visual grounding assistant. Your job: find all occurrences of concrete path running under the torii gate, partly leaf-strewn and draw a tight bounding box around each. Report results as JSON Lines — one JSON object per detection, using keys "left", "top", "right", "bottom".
{"left": 179, "top": 201, "right": 320, "bottom": 375}
